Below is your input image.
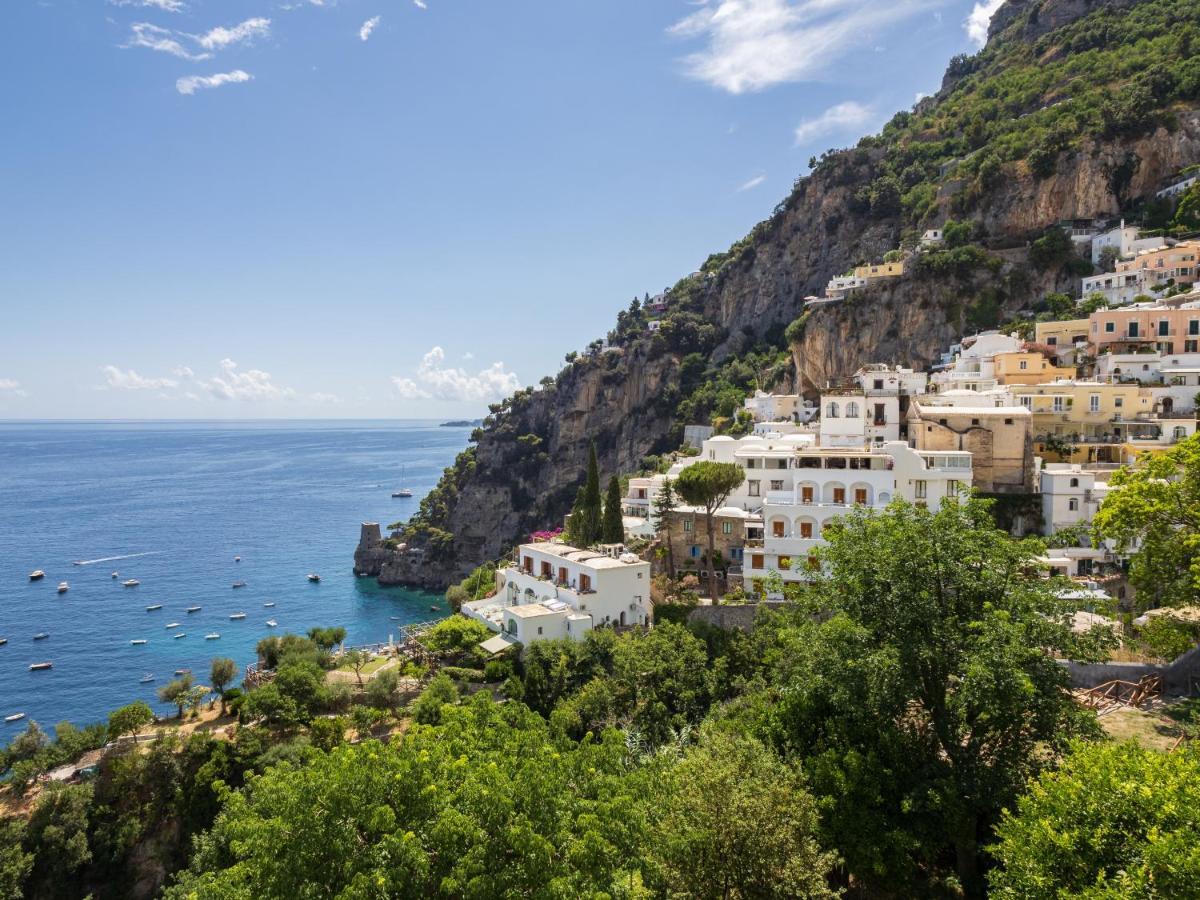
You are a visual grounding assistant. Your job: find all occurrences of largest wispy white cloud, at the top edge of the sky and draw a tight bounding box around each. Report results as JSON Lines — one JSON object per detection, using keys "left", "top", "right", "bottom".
{"left": 668, "top": 0, "right": 930, "bottom": 94}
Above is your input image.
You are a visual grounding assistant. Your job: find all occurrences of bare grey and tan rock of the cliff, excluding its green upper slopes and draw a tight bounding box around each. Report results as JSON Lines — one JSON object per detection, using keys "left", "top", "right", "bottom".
{"left": 356, "top": 0, "right": 1200, "bottom": 588}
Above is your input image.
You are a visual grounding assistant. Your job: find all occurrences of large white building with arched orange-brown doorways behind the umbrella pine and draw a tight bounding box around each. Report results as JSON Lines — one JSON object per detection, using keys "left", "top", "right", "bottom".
{"left": 743, "top": 442, "right": 972, "bottom": 595}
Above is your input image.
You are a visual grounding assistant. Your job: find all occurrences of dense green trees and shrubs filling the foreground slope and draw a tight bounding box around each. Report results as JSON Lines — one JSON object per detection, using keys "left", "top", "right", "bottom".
{"left": 9, "top": 500, "right": 1196, "bottom": 898}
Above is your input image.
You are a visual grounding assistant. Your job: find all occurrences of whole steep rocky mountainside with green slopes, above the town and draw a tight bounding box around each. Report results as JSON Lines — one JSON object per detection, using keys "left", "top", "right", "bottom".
{"left": 355, "top": 0, "right": 1200, "bottom": 588}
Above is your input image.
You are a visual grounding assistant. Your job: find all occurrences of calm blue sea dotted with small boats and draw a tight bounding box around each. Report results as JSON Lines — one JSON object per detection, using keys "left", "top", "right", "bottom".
{"left": 0, "top": 420, "right": 469, "bottom": 745}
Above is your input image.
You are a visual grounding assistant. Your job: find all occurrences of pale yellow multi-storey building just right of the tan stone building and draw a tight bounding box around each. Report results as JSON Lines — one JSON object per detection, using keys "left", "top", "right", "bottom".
{"left": 1012, "top": 380, "right": 1160, "bottom": 462}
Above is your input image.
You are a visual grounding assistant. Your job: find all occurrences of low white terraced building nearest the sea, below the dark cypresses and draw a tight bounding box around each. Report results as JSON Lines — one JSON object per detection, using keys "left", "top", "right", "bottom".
{"left": 462, "top": 542, "right": 650, "bottom": 644}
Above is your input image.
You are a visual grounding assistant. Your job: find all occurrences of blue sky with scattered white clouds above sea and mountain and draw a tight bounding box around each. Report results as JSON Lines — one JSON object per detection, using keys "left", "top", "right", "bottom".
{"left": 0, "top": 0, "right": 996, "bottom": 418}
